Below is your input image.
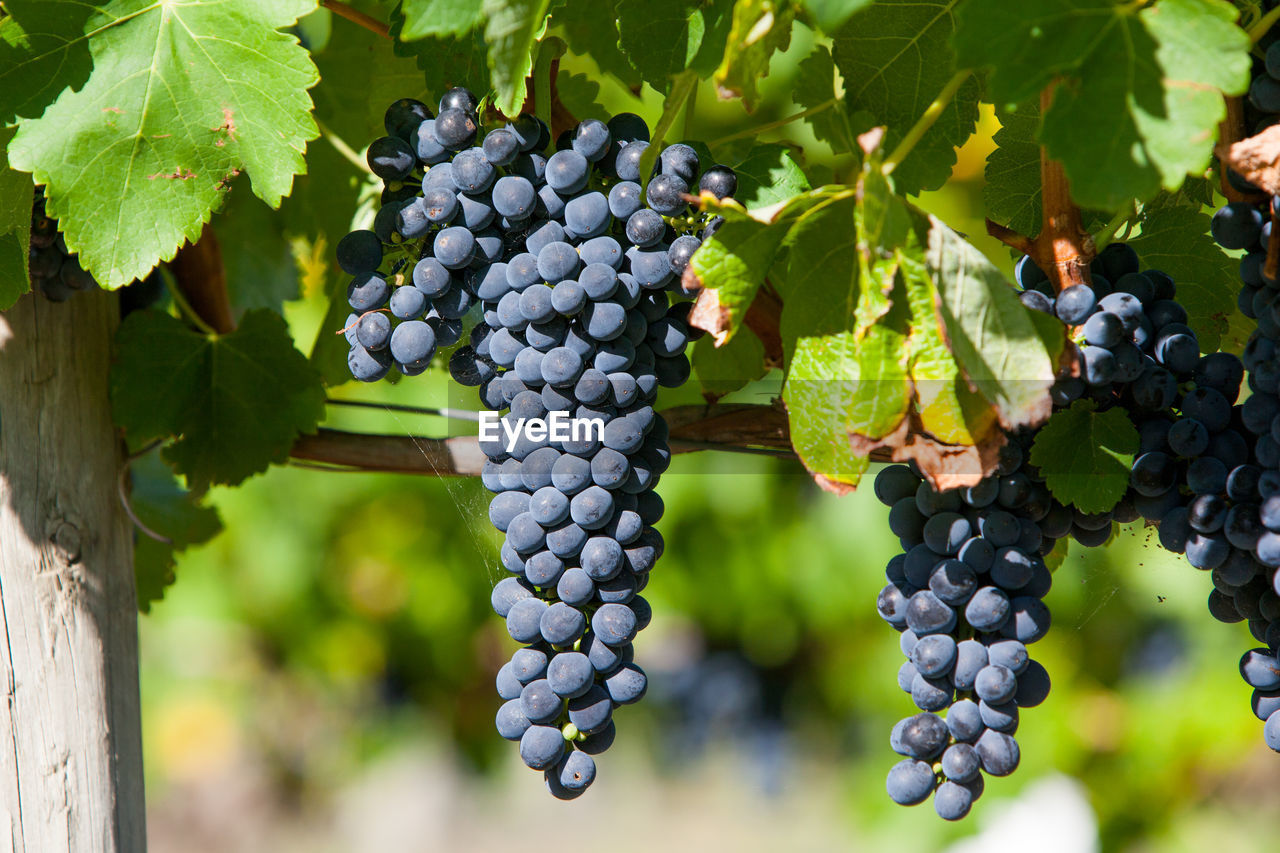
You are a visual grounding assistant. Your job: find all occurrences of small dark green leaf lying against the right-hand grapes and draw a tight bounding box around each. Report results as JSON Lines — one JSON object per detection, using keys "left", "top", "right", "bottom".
{"left": 1030, "top": 400, "right": 1138, "bottom": 512}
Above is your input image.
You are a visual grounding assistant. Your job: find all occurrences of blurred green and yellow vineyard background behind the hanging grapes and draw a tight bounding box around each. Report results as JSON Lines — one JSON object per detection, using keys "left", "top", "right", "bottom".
{"left": 141, "top": 13, "right": 1280, "bottom": 853}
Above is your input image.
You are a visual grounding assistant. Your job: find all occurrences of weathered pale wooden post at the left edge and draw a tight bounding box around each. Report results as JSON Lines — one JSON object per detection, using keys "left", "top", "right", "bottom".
{"left": 0, "top": 291, "right": 146, "bottom": 853}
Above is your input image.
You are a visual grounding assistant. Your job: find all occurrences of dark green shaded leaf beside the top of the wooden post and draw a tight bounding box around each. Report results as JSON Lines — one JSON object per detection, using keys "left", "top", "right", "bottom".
{"left": 111, "top": 310, "right": 324, "bottom": 492}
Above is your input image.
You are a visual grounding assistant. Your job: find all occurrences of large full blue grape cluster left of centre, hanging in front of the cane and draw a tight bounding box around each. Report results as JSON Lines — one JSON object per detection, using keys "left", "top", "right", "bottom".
{"left": 338, "top": 88, "right": 737, "bottom": 799}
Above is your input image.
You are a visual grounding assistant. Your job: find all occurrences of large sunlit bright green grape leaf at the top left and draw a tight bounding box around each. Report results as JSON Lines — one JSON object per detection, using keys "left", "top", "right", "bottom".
{"left": 9, "top": 0, "right": 317, "bottom": 288}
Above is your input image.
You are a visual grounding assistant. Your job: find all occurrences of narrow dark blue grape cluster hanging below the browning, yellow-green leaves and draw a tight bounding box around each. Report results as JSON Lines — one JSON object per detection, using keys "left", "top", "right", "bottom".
{"left": 874, "top": 435, "right": 1054, "bottom": 821}
